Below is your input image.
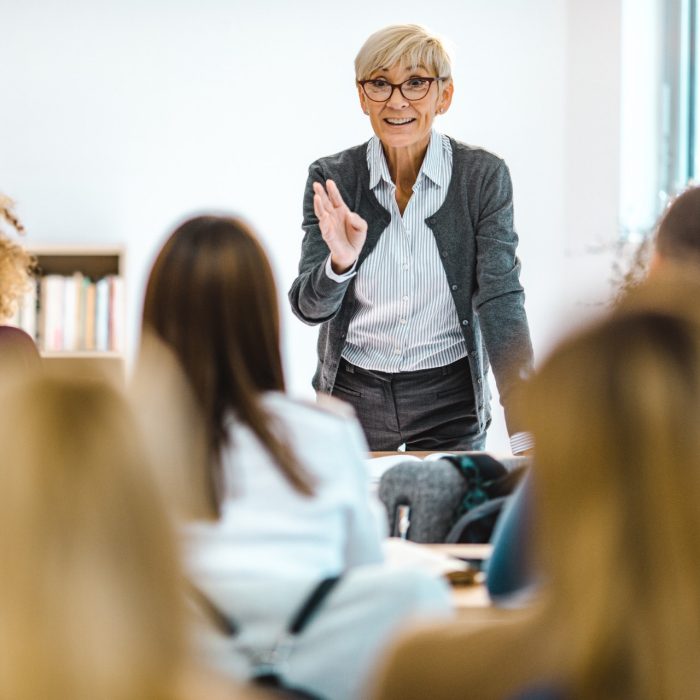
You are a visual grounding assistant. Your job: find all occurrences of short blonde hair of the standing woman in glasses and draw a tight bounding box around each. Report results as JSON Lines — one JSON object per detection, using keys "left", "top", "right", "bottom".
{"left": 355, "top": 24, "right": 452, "bottom": 80}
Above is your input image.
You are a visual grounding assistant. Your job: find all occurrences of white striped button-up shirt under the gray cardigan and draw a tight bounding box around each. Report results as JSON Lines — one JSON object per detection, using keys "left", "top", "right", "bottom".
{"left": 326, "top": 131, "right": 467, "bottom": 372}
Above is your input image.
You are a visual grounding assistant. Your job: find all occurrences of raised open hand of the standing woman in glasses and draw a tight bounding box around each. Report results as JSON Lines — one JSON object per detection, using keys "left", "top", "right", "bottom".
{"left": 313, "top": 180, "right": 367, "bottom": 274}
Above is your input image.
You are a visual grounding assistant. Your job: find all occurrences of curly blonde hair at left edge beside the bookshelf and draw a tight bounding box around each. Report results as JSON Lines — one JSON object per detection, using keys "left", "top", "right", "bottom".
{"left": 0, "top": 194, "right": 36, "bottom": 323}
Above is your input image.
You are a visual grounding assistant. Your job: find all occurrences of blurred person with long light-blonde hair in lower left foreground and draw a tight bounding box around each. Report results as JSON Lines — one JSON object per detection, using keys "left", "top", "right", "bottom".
{"left": 0, "top": 376, "right": 254, "bottom": 700}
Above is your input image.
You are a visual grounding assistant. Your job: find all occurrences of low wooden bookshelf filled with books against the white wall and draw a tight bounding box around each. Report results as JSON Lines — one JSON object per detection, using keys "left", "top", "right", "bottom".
{"left": 19, "top": 244, "right": 126, "bottom": 383}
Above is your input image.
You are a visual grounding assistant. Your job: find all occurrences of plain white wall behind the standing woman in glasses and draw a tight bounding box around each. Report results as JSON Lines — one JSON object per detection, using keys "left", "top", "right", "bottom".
{"left": 0, "top": 0, "right": 636, "bottom": 449}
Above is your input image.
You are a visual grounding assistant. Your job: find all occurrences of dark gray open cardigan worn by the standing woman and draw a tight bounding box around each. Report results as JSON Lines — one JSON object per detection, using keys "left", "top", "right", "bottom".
{"left": 289, "top": 139, "right": 533, "bottom": 435}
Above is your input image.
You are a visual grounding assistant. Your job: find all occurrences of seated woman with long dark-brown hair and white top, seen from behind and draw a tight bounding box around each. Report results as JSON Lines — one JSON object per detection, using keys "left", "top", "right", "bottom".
{"left": 143, "top": 216, "right": 382, "bottom": 581}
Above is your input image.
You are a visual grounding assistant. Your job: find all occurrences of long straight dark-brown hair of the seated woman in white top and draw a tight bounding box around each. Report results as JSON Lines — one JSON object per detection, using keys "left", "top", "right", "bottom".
{"left": 143, "top": 216, "right": 313, "bottom": 514}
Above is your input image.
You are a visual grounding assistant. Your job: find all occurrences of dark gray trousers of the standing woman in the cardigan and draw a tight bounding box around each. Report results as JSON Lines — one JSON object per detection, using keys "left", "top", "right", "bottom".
{"left": 332, "top": 358, "right": 486, "bottom": 451}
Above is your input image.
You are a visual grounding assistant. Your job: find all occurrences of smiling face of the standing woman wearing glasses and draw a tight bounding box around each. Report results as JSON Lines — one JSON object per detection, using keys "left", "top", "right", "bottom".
{"left": 358, "top": 64, "right": 453, "bottom": 153}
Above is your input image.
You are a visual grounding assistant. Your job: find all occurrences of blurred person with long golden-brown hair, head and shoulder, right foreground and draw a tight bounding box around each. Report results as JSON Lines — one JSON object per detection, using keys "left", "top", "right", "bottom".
{"left": 374, "top": 282, "right": 700, "bottom": 700}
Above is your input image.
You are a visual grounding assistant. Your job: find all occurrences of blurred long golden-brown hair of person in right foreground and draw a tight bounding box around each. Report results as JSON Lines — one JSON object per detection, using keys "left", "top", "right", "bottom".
{"left": 526, "top": 278, "right": 700, "bottom": 698}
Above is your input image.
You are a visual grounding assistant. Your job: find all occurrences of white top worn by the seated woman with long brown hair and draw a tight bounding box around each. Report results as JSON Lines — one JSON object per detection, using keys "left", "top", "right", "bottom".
{"left": 185, "top": 393, "right": 386, "bottom": 584}
